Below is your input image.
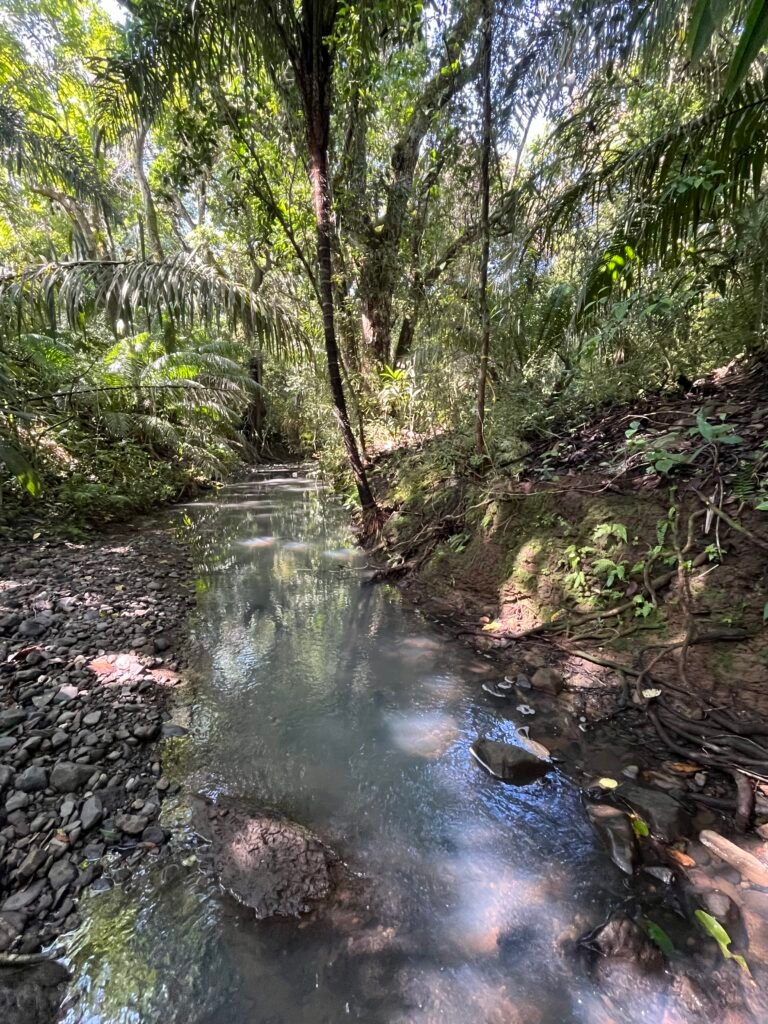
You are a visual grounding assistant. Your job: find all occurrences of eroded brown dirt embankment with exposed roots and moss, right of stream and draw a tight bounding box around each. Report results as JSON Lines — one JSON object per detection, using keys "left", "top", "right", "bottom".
{"left": 374, "top": 364, "right": 768, "bottom": 1011}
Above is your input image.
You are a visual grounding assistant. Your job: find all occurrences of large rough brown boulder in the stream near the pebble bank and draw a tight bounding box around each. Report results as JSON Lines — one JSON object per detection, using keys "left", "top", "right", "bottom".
{"left": 195, "top": 790, "right": 338, "bottom": 920}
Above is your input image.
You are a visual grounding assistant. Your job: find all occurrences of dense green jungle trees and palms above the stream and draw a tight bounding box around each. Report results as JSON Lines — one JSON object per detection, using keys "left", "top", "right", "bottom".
{"left": 0, "top": 0, "right": 768, "bottom": 524}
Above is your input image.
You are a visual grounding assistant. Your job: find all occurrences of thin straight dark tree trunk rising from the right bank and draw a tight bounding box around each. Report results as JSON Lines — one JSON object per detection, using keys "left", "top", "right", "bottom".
{"left": 475, "top": 0, "right": 494, "bottom": 455}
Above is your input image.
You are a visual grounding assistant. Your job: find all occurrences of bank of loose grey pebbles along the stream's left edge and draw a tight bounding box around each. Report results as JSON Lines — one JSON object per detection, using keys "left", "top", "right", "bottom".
{"left": 0, "top": 523, "right": 194, "bottom": 953}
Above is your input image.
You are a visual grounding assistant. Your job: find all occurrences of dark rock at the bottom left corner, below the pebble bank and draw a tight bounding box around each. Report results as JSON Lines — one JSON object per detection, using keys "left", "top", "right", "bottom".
{"left": 0, "top": 956, "right": 70, "bottom": 1024}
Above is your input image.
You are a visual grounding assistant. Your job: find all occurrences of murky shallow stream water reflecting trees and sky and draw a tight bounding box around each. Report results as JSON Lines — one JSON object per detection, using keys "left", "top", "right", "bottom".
{"left": 61, "top": 468, "right": 658, "bottom": 1024}
